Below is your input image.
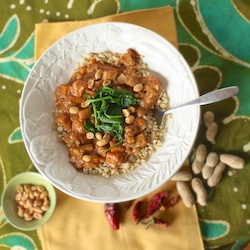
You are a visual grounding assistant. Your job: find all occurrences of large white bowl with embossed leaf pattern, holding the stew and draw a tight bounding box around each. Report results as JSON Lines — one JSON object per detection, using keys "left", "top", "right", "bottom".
{"left": 20, "top": 22, "right": 200, "bottom": 202}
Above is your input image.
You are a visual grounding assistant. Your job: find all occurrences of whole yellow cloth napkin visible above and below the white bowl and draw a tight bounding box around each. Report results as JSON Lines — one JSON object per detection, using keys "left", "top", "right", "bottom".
{"left": 35, "top": 7, "right": 203, "bottom": 250}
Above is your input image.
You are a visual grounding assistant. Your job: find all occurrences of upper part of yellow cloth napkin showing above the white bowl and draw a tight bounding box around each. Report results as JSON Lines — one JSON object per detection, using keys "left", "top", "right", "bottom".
{"left": 35, "top": 7, "right": 178, "bottom": 59}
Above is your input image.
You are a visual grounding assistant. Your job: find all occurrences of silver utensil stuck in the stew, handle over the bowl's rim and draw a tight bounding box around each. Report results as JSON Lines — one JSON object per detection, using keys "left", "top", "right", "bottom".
{"left": 153, "top": 86, "right": 239, "bottom": 125}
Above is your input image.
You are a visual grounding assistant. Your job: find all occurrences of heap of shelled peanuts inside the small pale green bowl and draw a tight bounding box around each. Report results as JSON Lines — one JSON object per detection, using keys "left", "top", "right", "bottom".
{"left": 15, "top": 184, "right": 50, "bottom": 221}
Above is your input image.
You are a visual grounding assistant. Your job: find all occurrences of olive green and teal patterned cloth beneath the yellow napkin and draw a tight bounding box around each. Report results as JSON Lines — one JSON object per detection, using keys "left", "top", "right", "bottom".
{"left": 0, "top": 0, "right": 250, "bottom": 249}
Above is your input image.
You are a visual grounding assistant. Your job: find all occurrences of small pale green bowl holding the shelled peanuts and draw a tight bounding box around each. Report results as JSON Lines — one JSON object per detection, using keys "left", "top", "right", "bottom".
{"left": 1, "top": 172, "right": 56, "bottom": 231}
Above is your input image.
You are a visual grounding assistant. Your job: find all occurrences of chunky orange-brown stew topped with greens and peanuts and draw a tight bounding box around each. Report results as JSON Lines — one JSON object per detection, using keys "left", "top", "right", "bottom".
{"left": 55, "top": 49, "right": 167, "bottom": 177}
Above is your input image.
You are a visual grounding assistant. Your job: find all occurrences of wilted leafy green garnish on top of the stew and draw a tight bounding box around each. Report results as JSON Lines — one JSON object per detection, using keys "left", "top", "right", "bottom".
{"left": 84, "top": 86, "right": 140, "bottom": 151}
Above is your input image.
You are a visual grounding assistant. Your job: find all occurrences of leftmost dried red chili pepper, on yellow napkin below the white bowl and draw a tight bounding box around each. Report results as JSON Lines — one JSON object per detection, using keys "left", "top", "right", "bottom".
{"left": 104, "top": 203, "right": 120, "bottom": 230}
